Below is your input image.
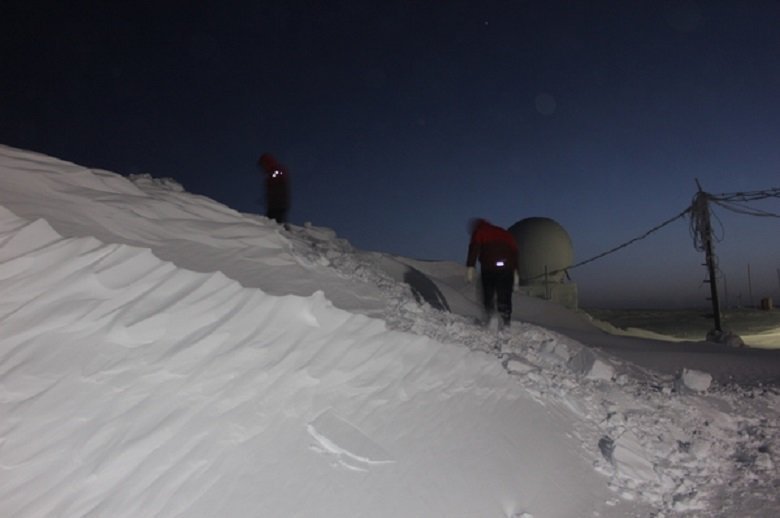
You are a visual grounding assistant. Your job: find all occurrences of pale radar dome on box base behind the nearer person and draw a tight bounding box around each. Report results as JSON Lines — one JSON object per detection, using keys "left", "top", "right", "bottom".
{"left": 509, "top": 218, "right": 574, "bottom": 285}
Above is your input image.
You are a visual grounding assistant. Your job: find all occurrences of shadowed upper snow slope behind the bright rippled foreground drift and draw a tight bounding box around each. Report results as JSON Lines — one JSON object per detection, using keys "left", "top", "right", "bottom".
{"left": 0, "top": 146, "right": 390, "bottom": 313}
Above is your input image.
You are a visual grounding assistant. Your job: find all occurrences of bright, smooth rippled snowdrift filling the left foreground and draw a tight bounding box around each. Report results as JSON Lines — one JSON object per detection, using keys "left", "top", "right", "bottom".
{"left": 0, "top": 209, "right": 632, "bottom": 517}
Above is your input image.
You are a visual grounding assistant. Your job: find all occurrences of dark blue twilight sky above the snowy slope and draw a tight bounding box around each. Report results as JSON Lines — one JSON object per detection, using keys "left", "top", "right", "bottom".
{"left": 0, "top": 0, "right": 780, "bottom": 307}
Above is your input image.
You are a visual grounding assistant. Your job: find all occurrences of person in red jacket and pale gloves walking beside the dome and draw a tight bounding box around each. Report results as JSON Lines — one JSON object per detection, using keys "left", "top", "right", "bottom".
{"left": 466, "top": 219, "right": 518, "bottom": 325}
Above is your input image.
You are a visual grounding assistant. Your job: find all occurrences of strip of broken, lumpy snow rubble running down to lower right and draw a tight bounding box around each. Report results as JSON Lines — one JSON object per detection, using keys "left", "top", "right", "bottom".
{"left": 286, "top": 223, "right": 780, "bottom": 515}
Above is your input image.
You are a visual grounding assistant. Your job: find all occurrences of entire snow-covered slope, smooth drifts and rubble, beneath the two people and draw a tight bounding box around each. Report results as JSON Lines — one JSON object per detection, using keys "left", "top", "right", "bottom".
{"left": 0, "top": 146, "right": 780, "bottom": 518}
